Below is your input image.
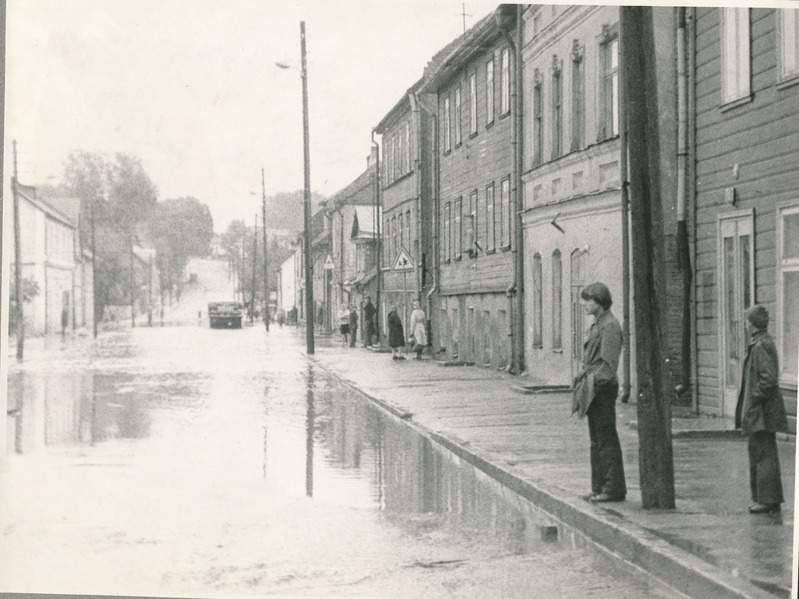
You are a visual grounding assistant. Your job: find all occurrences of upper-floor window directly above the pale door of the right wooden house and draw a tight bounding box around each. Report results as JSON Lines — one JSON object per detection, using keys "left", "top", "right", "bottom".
{"left": 720, "top": 8, "right": 750, "bottom": 104}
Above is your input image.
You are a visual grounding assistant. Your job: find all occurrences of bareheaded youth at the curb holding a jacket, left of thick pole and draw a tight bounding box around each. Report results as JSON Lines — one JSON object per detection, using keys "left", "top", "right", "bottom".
{"left": 573, "top": 283, "right": 627, "bottom": 503}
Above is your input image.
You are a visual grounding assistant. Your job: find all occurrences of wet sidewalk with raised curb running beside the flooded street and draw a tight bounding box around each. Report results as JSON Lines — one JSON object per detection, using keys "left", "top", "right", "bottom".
{"left": 314, "top": 338, "right": 795, "bottom": 599}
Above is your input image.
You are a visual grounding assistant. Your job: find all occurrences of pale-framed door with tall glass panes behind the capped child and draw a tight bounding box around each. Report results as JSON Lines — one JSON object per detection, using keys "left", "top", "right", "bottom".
{"left": 719, "top": 212, "right": 755, "bottom": 416}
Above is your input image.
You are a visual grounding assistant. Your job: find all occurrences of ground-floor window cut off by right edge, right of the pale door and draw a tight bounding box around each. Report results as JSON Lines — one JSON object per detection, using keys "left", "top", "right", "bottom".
{"left": 779, "top": 206, "right": 799, "bottom": 384}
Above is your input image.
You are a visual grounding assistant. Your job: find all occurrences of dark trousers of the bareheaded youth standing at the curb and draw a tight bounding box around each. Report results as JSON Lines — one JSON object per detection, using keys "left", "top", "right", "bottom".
{"left": 587, "top": 384, "right": 627, "bottom": 497}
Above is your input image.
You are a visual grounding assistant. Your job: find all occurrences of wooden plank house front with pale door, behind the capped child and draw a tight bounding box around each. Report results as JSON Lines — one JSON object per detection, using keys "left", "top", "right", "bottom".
{"left": 692, "top": 8, "right": 799, "bottom": 430}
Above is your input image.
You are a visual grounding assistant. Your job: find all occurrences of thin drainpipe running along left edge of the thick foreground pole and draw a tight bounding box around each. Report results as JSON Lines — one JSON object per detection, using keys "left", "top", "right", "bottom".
{"left": 619, "top": 7, "right": 632, "bottom": 403}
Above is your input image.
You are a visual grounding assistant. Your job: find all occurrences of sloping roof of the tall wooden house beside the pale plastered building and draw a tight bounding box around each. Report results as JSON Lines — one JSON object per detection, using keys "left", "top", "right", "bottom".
{"left": 419, "top": 4, "right": 516, "bottom": 93}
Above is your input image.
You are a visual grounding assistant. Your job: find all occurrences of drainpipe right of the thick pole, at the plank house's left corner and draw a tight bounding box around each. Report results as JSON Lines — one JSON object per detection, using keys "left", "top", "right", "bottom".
{"left": 676, "top": 7, "right": 692, "bottom": 395}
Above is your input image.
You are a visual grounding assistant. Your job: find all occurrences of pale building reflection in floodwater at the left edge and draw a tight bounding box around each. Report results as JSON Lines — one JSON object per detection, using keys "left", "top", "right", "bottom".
{"left": 6, "top": 371, "right": 150, "bottom": 453}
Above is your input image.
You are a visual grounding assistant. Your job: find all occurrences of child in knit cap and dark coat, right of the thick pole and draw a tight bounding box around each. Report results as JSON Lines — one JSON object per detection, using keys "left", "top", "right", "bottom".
{"left": 735, "top": 304, "right": 788, "bottom": 514}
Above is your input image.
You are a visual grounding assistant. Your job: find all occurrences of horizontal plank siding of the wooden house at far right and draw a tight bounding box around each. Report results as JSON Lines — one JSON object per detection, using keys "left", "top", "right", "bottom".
{"left": 695, "top": 8, "right": 799, "bottom": 422}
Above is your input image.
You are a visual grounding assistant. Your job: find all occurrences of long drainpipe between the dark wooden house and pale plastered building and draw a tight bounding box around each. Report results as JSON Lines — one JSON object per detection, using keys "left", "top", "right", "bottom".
{"left": 495, "top": 4, "right": 524, "bottom": 374}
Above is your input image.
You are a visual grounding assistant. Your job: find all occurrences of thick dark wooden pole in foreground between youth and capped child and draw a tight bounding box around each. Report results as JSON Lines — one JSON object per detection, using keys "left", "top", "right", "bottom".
{"left": 619, "top": 6, "right": 675, "bottom": 509}
